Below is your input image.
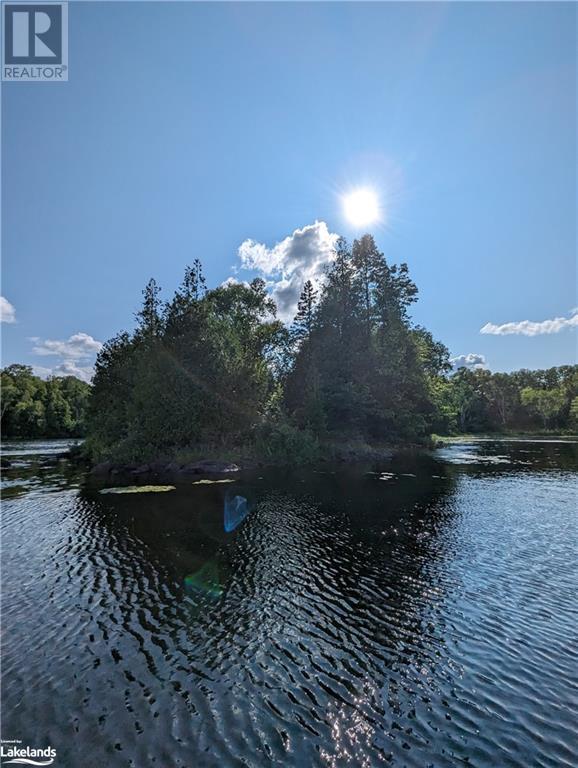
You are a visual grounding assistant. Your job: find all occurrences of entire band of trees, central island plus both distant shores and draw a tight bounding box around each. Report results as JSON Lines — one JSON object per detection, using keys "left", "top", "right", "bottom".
{"left": 10, "top": 235, "right": 578, "bottom": 461}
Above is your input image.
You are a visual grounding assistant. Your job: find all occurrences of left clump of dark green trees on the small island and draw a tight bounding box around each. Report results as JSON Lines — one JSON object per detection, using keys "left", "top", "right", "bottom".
{"left": 87, "top": 262, "right": 284, "bottom": 460}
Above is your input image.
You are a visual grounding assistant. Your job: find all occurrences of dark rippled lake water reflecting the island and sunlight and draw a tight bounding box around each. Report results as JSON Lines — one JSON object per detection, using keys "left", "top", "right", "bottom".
{"left": 2, "top": 442, "right": 578, "bottom": 768}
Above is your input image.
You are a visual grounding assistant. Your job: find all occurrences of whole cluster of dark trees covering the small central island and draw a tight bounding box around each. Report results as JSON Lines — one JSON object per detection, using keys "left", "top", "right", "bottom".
{"left": 84, "top": 235, "right": 449, "bottom": 457}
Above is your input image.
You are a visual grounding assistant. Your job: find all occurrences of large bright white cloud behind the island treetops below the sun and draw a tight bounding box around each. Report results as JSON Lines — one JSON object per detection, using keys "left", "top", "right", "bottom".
{"left": 238, "top": 221, "right": 339, "bottom": 321}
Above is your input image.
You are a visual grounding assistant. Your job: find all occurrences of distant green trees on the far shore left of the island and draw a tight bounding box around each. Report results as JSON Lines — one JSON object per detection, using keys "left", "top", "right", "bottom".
{"left": 1, "top": 365, "right": 91, "bottom": 438}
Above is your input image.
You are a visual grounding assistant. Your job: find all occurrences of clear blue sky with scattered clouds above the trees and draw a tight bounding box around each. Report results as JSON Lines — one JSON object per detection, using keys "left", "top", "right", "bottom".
{"left": 0, "top": 2, "right": 578, "bottom": 379}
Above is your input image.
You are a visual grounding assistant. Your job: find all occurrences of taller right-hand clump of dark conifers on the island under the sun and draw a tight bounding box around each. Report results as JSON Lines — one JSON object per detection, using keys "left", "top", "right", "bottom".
{"left": 285, "top": 235, "right": 448, "bottom": 441}
